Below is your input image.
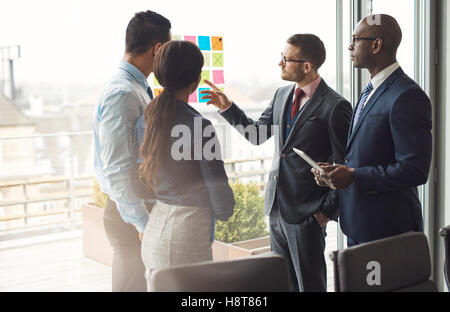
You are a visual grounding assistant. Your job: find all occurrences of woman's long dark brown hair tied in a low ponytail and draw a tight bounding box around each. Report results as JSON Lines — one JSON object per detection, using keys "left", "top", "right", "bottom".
{"left": 139, "top": 41, "right": 203, "bottom": 191}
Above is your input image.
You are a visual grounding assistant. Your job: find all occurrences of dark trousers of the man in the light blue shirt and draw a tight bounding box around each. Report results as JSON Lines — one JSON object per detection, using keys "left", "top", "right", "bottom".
{"left": 103, "top": 200, "right": 147, "bottom": 292}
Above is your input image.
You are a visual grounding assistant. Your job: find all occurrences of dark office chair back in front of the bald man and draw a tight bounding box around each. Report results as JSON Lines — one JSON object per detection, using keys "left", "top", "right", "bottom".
{"left": 331, "top": 232, "right": 437, "bottom": 292}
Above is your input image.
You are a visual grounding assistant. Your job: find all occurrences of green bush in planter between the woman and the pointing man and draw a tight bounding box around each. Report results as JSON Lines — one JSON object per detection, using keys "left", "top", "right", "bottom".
{"left": 215, "top": 182, "right": 269, "bottom": 243}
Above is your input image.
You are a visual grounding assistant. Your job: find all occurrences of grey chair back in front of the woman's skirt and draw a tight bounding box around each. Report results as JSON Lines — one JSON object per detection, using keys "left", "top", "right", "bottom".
{"left": 150, "top": 253, "right": 289, "bottom": 292}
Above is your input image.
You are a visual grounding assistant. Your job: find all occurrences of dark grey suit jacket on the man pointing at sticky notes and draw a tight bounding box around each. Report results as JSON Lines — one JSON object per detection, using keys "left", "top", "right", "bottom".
{"left": 221, "top": 79, "right": 352, "bottom": 224}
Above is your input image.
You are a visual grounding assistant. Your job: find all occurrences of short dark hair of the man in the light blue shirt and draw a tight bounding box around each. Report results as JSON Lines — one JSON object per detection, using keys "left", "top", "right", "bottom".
{"left": 125, "top": 10, "right": 171, "bottom": 55}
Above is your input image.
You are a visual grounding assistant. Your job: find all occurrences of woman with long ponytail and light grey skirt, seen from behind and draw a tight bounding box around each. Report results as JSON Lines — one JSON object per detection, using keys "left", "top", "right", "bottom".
{"left": 139, "top": 41, "right": 234, "bottom": 288}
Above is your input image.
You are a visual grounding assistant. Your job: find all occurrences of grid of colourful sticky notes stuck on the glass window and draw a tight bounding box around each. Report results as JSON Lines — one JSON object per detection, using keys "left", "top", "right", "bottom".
{"left": 148, "top": 34, "right": 225, "bottom": 103}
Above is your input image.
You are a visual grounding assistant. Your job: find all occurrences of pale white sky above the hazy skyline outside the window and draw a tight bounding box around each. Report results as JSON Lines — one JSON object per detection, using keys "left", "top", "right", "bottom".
{"left": 0, "top": 0, "right": 335, "bottom": 100}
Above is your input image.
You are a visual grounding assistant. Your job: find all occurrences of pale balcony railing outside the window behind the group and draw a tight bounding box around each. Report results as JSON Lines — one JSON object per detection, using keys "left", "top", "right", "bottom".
{"left": 0, "top": 132, "right": 272, "bottom": 234}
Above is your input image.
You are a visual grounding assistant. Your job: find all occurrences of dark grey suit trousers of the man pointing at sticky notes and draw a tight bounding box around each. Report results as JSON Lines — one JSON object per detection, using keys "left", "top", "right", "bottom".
{"left": 269, "top": 204, "right": 327, "bottom": 292}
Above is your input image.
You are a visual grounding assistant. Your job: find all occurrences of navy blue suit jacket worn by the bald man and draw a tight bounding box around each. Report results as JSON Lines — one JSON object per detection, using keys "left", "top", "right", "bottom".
{"left": 339, "top": 68, "right": 432, "bottom": 242}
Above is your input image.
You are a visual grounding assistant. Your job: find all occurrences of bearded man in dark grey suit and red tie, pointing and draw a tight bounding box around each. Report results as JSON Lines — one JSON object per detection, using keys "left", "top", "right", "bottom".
{"left": 203, "top": 34, "right": 352, "bottom": 291}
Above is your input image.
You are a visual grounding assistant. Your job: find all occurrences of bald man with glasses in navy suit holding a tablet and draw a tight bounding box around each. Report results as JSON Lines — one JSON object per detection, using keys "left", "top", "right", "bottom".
{"left": 313, "top": 15, "right": 432, "bottom": 247}
